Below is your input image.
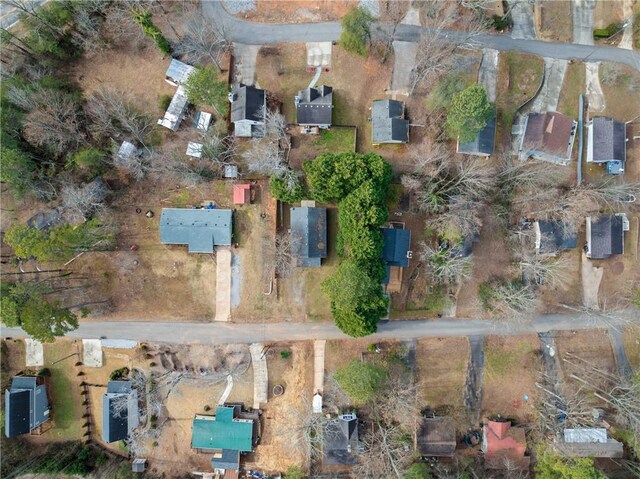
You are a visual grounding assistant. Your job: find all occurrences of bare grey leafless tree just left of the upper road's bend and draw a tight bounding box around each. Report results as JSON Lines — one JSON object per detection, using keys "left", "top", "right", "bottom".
{"left": 174, "top": 13, "right": 231, "bottom": 71}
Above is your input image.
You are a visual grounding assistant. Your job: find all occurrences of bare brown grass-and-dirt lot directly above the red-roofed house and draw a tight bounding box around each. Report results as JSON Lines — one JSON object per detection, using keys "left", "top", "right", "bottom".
{"left": 482, "top": 335, "right": 541, "bottom": 422}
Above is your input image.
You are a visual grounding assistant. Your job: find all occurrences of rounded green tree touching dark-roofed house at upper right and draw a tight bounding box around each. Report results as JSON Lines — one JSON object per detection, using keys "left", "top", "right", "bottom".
{"left": 446, "top": 84, "right": 493, "bottom": 143}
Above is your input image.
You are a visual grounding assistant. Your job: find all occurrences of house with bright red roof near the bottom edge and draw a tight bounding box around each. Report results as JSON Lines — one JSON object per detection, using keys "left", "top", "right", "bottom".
{"left": 482, "top": 421, "right": 531, "bottom": 469}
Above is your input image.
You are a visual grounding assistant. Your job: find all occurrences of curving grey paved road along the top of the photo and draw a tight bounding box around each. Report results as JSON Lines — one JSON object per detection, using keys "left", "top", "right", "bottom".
{"left": 202, "top": 0, "right": 640, "bottom": 71}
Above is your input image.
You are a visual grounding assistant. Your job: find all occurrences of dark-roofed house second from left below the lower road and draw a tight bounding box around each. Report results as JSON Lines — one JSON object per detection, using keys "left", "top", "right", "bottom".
{"left": 102, "top": 381, "right": 138, "bottom": 443}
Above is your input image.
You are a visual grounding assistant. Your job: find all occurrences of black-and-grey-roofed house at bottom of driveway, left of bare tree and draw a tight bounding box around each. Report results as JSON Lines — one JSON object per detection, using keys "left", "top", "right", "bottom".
{"left": 229, "top": 83, "right": 267, "bottom": 138}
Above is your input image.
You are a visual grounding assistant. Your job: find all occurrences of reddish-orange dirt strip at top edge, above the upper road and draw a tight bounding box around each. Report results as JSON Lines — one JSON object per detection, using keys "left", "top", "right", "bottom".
{"left": 231, "top": 0, "right": 358, "bottom": 23}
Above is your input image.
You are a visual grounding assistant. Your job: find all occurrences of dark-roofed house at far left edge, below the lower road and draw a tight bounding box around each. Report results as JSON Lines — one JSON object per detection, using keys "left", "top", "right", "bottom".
{"left": 4, "top": 376, "right": 49, "bottom": 437}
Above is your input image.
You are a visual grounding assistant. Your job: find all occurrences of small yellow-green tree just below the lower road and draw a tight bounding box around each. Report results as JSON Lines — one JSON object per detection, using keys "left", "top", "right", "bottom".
{"left": 335, "top": 360, "right": 388, "bottom": 404}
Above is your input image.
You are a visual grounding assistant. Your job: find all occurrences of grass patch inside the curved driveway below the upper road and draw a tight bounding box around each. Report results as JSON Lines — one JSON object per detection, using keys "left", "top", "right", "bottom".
{"left": 496, "top": 52, "right": 544, "bottom": 132}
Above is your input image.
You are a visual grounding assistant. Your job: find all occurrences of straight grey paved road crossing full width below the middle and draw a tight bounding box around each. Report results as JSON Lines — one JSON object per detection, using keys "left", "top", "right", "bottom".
{"left": 0, "top": 314, "right": 636, "bottom": 344}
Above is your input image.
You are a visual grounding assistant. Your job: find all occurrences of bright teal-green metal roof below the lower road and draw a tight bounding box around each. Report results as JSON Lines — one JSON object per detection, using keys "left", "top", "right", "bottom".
{"left": 191, "top": 406, "right": 253, "bottom": 452}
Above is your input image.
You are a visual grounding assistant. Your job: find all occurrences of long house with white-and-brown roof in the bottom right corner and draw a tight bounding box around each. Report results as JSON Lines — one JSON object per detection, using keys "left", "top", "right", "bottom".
{"left": 552, "top": 428, "right": 624, "bottom": 458}
